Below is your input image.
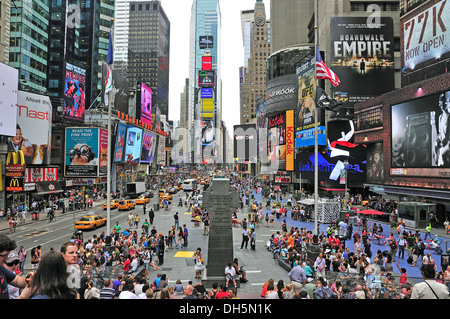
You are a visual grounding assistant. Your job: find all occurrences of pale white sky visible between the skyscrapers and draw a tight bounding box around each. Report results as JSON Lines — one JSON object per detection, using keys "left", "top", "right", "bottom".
{"left": 161, "top": 0, "right": 270, "bottom": 132}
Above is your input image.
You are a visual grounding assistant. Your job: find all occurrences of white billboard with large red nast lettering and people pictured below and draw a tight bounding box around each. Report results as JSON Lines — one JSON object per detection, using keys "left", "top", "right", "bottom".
{"left": 8, "top": 91, "right": 52, "bottom": 165}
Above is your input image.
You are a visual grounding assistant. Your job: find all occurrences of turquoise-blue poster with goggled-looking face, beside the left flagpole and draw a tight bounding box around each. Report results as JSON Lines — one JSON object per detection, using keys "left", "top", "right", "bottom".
{"left": 64, "top": 127, "right": 100, "bottom": 177}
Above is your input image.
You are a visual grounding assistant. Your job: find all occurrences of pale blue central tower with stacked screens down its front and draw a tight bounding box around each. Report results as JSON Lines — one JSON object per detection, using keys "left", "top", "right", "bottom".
{"left": 186, "top": 0, "right": 222, "bottom": 163}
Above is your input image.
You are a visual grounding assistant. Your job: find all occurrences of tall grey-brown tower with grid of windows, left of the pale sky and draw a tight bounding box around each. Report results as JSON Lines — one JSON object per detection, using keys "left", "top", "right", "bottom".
{"left": 127, "top": 1, "right": 170, "bottom": 118}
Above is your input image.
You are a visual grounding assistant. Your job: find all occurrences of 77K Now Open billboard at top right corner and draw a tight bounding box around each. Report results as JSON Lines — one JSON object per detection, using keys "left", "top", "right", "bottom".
{"left": 400, "top": 0, "right": 450, "bottom": 86}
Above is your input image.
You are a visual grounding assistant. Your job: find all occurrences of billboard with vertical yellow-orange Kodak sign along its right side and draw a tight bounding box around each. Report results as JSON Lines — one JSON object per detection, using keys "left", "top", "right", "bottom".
{"left": 267, "top": 110, "right": 295, "bottom": 171}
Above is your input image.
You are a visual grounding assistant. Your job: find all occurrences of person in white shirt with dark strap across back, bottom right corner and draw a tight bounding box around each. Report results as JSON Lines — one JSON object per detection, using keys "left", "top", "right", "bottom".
{"left": 411, "top": 264, "right": 450, "bottom": 299}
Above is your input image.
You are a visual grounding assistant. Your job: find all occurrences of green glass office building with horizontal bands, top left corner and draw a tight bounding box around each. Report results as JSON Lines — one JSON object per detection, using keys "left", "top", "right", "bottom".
{"left": 9, "top": 0, "right": 50, "bottom": 93}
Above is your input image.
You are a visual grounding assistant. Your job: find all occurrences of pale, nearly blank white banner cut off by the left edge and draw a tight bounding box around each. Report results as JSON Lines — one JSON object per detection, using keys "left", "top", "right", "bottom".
{"left": 0, "top": 63, "right": 19, "bottom": 136}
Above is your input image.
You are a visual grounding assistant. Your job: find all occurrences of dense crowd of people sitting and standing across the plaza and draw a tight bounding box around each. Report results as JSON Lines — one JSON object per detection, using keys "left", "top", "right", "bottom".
{"left": 0, "top": 172, "right": 450, "bottom": 299}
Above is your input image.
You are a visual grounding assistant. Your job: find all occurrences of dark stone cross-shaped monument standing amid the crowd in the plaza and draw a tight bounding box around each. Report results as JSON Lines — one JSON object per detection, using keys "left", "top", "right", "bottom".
{"left": 202, "top": 178, "right": 239, "bottom": 287}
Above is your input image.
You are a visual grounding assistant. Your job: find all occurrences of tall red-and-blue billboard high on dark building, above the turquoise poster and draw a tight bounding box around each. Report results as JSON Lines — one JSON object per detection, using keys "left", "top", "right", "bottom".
{"left": 64, "top": 63, "right": 86, "bottom": 122}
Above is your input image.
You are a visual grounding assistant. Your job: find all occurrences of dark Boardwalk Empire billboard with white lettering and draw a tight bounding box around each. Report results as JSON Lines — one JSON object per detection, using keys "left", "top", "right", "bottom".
{"left": 328, "top": 17, "right": 394, "bottom": 108}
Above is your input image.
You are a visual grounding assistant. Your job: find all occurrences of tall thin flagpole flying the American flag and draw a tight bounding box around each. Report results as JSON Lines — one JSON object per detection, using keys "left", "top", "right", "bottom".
{"left": 313, "top": 0, "right": 319, "bottom": 243}
